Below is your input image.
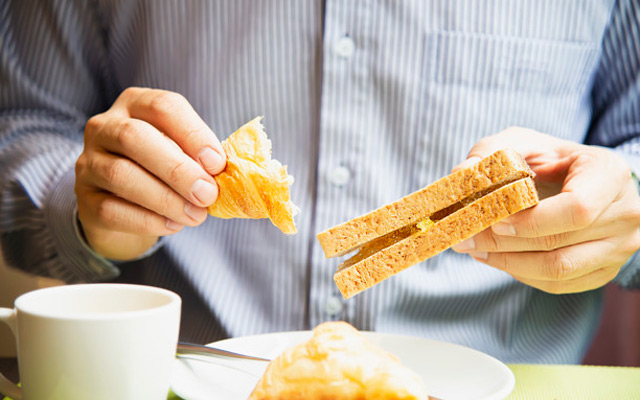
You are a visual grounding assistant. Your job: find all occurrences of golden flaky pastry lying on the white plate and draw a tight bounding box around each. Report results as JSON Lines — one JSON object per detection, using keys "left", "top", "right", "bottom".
{"left": 249, "top": 322, "right": 429, "bottom": 400}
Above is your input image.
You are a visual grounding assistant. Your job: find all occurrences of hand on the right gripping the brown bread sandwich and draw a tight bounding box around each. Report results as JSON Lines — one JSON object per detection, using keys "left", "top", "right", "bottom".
{"left": 453, "top": 127, "right": 640, "bottom": 294}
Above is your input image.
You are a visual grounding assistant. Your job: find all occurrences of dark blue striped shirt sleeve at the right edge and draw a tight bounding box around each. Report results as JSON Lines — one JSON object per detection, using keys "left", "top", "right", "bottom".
{"left": 587, "top": 0, "right": 640, "bottom": 288}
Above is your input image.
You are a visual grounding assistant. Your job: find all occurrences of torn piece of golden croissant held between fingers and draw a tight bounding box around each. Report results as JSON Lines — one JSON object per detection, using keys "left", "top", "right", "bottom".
{"left": 207, "top": 117, "right": 298, "bottom": 234}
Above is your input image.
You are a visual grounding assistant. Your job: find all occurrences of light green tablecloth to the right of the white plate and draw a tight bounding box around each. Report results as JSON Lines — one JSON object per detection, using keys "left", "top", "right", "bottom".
{"left": 5, "top": 364, "right": 640, "bottom": 400}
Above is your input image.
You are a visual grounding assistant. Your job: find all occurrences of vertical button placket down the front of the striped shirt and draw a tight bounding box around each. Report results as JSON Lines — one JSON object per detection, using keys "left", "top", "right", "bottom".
{"left": 309, "top": 0, "right": 370, "bottom": 326}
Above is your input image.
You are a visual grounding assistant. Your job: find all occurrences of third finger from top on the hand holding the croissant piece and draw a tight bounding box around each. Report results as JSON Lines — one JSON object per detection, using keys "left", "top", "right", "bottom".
{"left": 78, "top": 152, "right": 207, "bottom": 226}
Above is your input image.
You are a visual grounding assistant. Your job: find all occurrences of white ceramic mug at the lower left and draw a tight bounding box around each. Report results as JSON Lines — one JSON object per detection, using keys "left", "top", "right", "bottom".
{"left": 0, "top": 284, "right": 181, "bottom": 400}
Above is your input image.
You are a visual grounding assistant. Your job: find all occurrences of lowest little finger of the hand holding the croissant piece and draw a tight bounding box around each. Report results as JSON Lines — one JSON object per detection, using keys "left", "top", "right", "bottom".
{"left": 78, "top": 191, "right": 183, "bottom": 236}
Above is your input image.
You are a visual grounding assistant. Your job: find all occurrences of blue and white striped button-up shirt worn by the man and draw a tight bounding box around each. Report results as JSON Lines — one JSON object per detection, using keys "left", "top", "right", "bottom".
{"left": 0, "top": 0, "right": 640, "bottom": 363}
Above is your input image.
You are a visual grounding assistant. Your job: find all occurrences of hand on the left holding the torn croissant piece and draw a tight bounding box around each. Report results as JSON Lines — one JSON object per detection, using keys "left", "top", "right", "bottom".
{"left": 75, "top": 88, "right": 226, "bottom": 260}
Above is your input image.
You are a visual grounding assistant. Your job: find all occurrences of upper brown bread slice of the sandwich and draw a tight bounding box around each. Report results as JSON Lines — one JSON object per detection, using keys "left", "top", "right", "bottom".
{"left": 317, "top": 149, "right": 534, "bottom": 258}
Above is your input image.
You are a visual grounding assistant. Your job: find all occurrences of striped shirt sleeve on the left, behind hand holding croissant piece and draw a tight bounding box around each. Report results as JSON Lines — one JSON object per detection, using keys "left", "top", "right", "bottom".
{"left": 0, "top": 0, "right": 118, "bottom": 283}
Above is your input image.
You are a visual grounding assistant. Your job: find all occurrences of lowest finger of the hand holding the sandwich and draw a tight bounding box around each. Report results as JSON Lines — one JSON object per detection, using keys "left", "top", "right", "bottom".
{"left": 469, "top": 240, "right": 630, "bottom": 281}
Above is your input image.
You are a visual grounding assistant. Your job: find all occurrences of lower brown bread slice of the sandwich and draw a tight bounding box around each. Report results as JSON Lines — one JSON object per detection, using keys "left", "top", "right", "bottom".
{"left": 333, "top": 174, "right": 538, "bottom": 299}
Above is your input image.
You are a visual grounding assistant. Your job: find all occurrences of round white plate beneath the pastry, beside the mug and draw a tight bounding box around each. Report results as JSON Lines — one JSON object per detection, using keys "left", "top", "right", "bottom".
{"left": 171, "top": 331, "right": 515, "bottom": 400}
